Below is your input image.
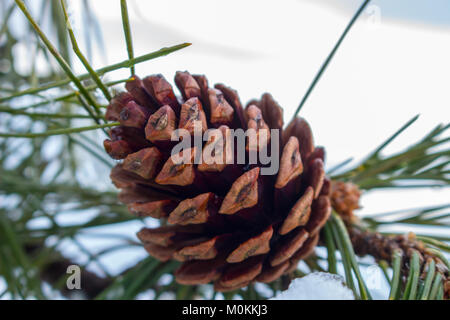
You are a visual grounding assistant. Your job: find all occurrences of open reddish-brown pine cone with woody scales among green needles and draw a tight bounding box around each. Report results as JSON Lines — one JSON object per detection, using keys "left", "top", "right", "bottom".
{"left": 104, "top": 72, "right": 330, "bottom": 291}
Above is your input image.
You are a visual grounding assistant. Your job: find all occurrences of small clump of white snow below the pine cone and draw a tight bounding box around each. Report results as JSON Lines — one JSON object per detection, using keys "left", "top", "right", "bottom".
{"left": 271, "top": 272, "right": 355, "bottom": 300}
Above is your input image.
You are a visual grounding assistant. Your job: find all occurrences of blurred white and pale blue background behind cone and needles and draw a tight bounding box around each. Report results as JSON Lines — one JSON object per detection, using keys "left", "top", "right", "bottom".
{"left": 0, "top": 0, "right": 450, "bottom": 298}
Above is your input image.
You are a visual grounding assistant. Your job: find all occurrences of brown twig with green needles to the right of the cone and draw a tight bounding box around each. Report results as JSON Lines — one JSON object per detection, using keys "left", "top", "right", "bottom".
{"left": 332, "top": 116, "right": 450, "bottom": 299}
